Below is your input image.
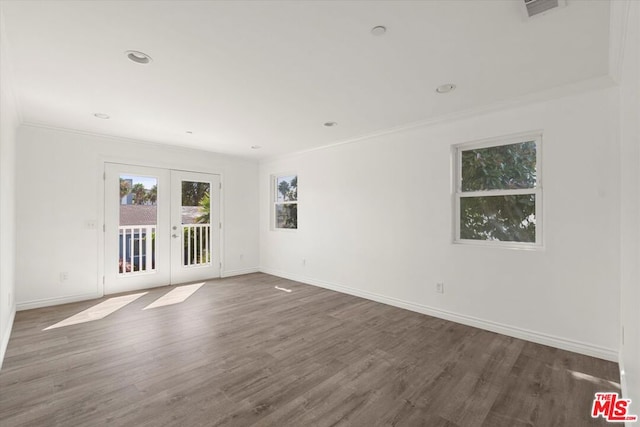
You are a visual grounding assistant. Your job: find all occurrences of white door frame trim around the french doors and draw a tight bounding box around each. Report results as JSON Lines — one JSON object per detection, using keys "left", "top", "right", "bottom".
{"left": 95, "top": 155, "right": 225, "bottom": 298}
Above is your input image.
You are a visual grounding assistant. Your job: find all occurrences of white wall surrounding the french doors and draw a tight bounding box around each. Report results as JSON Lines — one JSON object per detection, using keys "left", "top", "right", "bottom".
{"left": 16, "top": 126, "right": 259, "bottom": 309}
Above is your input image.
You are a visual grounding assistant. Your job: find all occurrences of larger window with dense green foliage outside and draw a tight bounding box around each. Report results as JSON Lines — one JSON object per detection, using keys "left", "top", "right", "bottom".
{"left": 454, "top": 134, "right": 542, "bottom": 248}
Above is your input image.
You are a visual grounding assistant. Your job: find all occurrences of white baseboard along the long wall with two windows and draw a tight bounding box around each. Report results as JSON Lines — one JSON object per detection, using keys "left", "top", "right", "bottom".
{"left": 260, "top": 268, "right": 618, "bottom": 362}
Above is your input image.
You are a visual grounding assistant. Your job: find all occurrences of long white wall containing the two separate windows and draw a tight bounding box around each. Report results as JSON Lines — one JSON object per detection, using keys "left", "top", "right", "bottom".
{"left": 260, "top": 88, "right": 620, "bottom": 360}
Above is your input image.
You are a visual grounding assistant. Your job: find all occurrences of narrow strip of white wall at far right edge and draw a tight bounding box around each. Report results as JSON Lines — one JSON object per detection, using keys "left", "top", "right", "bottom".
{"left": 620, "top": 2, "right": 640, "bottom": 414}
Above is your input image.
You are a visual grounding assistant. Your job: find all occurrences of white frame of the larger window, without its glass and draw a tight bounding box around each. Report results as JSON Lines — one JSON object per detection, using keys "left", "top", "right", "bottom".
{"left": 451, "top": 131, "right": 544, "bottom": 250}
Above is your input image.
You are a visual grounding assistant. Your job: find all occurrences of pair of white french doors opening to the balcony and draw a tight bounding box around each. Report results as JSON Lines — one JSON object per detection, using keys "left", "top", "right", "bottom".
{"left": 104, "top": 163, "right": 221, "bottom": 294}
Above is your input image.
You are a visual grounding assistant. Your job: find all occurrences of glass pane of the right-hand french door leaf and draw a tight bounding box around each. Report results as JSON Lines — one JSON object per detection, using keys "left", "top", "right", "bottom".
{"left": 180, "top": 181, "right": 211, "bottom": 267}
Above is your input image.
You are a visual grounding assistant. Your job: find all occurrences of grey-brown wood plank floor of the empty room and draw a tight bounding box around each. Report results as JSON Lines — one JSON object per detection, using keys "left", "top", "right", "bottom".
{"left": 0, "top": 273, "right": 619, "bottom": 427}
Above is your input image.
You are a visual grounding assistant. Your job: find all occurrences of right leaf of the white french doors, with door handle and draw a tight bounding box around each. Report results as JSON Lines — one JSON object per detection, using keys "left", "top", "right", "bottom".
{"left": 171, "top": 170, "right": 221, "bottom": 284}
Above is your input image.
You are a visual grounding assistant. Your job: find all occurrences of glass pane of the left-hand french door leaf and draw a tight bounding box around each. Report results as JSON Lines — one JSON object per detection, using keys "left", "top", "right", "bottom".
{"left": 118, "top": 174, "right": 158, "bottom": 275}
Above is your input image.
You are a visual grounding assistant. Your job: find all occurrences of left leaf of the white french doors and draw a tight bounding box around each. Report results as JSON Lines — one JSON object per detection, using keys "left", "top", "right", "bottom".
{"left": 104, "top": 163, "right": 171, "bottom": 294}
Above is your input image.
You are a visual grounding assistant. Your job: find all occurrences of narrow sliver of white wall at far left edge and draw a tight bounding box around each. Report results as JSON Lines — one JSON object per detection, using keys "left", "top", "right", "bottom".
{"left": 0, "top": 6, "right": 19, "bottom": 366}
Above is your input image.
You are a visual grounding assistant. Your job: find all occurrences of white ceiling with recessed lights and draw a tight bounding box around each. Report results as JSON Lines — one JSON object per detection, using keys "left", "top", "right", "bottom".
{"left": 1, "top": 0, "right": 610, "bottom": 158}
